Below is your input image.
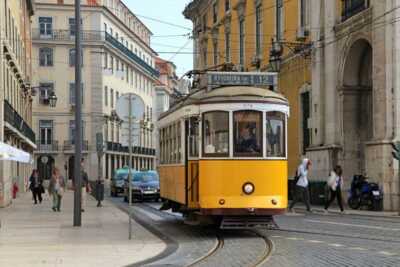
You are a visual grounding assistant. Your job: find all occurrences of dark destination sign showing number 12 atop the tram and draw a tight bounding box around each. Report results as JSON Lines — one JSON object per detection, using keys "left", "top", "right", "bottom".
{"left": 207, "top": 72, "right": 278, "bottom": 88}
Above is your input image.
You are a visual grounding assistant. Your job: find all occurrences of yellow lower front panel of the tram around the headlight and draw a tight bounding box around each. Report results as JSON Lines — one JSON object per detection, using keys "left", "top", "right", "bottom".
{"left": 199, "top": 160, "right": 288, "bottom": 214}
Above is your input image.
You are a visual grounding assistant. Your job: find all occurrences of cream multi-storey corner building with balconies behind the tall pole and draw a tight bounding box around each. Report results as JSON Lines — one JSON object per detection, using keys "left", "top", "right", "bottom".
{"left": 32, "top": 0, "right": 158, "bottom": 182}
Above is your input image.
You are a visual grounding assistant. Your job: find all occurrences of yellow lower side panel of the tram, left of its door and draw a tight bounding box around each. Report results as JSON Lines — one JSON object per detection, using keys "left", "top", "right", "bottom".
{"left": 159, "top": 165, "right": 185, "bottom": 204}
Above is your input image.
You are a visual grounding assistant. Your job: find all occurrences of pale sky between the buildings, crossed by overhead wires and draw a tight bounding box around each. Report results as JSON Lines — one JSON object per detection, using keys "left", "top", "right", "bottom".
{"left": 123, "top": 0, "right": 193, "bottom": 77}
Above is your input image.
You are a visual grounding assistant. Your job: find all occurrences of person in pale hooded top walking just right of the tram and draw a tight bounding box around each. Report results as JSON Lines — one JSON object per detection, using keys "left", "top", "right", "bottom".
{"left": 289, "top": 159, "right": 311, "bottom": 212}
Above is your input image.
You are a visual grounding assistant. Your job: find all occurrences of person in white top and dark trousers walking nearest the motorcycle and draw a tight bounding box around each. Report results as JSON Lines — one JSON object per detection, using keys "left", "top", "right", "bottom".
{"left": 324, "top": 165, "right": 344, "bottom": 213}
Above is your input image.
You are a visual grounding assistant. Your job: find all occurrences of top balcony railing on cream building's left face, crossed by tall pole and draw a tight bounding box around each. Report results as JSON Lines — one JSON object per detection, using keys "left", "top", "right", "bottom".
{"left": 32, "top": 29, "right": 104, "bottom": 42}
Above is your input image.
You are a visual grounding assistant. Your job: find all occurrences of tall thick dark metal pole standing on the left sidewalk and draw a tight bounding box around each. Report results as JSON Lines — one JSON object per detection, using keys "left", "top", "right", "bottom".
{"left": 74, "top": 0, "right": 82, "bottom": 226}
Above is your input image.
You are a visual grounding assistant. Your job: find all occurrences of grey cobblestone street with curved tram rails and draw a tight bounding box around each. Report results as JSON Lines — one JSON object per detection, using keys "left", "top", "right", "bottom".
{"left": 114, "top": 200, "right": 400, "bottom": 266}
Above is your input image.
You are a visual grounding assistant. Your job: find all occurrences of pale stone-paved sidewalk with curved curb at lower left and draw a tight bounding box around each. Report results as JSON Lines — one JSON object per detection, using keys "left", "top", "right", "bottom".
{"left": 0, "top": 191, "right": 166, "bottom": 267}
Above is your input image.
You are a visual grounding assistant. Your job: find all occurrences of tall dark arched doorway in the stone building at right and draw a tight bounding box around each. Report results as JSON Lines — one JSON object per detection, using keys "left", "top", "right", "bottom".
{"left": 341, "top": 39, "right": 373, "bottom": 178}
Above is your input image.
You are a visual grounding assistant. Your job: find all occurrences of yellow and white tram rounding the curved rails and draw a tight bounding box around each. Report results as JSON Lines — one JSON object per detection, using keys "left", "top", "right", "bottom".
{"left": 158, "top": 72, "right": 289, "bottom": 228}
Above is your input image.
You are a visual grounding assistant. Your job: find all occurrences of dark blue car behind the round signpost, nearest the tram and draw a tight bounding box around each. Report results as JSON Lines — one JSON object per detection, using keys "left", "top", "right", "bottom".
{"left": 124, "top": 171, "right": 160, "bottom": 202}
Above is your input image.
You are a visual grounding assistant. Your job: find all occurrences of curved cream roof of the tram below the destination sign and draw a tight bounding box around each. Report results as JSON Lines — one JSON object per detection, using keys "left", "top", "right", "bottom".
{"left": 160, "top": 86, "right": 288, "bottom": 119}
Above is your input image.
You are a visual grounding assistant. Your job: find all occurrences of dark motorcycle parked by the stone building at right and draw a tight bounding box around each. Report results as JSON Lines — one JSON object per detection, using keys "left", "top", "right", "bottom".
{"left": 347, "top": 175, "right": 383, "bottom": 210}
